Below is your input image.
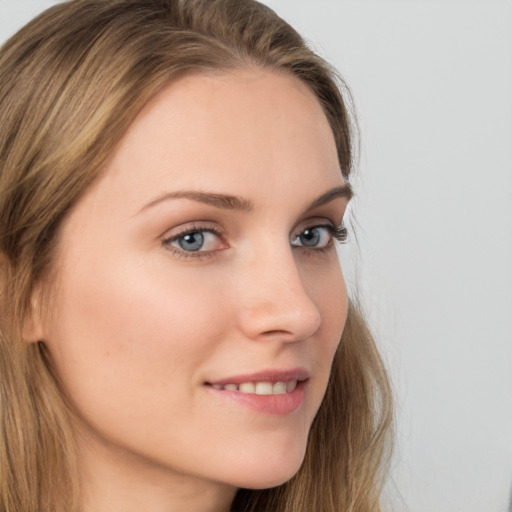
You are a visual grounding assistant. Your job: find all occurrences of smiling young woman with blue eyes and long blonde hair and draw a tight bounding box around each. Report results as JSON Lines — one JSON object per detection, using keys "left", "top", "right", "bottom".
{"left": 0, "top": 0, "right": 390, "bottom": 512}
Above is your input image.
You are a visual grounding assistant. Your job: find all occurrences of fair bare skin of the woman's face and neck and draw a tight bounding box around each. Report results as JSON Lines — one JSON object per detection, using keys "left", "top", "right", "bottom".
{"left": 32, "top": 69, "right": 347, "bottom": 512}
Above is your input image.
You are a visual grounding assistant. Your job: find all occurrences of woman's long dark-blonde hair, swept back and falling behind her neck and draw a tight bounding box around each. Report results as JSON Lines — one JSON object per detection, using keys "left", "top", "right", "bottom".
{"left": 0, "top": 0, "right": 391, "bottom": 512}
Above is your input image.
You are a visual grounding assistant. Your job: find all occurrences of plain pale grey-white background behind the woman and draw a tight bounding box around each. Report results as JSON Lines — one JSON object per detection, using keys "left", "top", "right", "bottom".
{"left": 0, "top": 0, "right": 512, "bottom": 512}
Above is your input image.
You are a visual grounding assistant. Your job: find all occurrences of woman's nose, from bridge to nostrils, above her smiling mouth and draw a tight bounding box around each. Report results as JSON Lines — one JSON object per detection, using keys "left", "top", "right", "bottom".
{"left": 235, "top": 247, "right": 322, "bottom": 342}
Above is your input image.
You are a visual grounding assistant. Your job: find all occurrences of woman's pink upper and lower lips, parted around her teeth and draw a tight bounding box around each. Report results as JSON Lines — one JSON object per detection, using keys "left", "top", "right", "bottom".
{"left": 205, "top": 368, "right": 309, "bottom": 416}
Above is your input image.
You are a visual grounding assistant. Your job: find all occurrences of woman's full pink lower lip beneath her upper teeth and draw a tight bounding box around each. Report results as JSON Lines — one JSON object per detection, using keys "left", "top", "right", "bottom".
{"left": 209, "top": 381, "right": 306, "bottom": 416}
